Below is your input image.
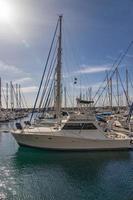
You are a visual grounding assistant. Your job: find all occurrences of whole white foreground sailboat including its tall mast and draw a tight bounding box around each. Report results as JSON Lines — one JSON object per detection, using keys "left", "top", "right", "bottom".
{"left": 11, "top": 16, "right": 133, "bottom": 151}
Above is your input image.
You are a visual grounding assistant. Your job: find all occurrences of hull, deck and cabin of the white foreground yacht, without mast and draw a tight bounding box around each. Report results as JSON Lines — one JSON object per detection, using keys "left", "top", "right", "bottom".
{"left": 12, "top": 113, "right": 133, "bottom": 150}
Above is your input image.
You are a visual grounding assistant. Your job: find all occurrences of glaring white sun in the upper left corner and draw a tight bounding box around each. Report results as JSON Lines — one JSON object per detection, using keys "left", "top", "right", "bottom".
{"left": 0, "top": 1, "right": 13, "bottom": 23}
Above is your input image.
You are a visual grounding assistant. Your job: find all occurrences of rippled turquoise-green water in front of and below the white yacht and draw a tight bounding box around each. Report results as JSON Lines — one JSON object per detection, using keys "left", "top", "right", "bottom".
{"left": 0, "top": 122, "right": 133, "bottom": 200}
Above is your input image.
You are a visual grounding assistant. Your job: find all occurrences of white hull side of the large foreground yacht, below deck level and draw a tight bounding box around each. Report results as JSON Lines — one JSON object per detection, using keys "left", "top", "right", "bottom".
{"left": 12, "top": 133, "right": 133, "bottom": 150}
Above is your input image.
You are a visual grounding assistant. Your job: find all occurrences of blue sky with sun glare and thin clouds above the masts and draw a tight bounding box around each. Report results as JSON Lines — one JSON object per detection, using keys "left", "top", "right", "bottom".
{"left": 0, "top": 0, "right": 133, "bottom": 106}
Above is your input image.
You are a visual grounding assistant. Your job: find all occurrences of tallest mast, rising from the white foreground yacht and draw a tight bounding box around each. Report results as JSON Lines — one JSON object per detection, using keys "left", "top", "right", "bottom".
{"left": 56, "top": 15, "right": 62, "bottom": 119}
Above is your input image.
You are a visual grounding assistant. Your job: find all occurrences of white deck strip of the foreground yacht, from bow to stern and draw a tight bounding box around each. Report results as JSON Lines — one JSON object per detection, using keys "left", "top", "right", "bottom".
{"left": 14, "top": 127, "right": 129, "bottom": 140}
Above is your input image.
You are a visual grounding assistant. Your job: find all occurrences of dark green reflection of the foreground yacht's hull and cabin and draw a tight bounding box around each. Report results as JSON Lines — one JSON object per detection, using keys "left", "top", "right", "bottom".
{"left": 14, "top": 147, "right": 131, "bottom": 182}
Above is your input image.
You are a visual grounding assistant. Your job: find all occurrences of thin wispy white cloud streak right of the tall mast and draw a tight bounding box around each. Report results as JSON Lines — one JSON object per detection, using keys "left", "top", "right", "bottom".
{"left": 76, "top": 65, "right": 110, "bottom": 74}
